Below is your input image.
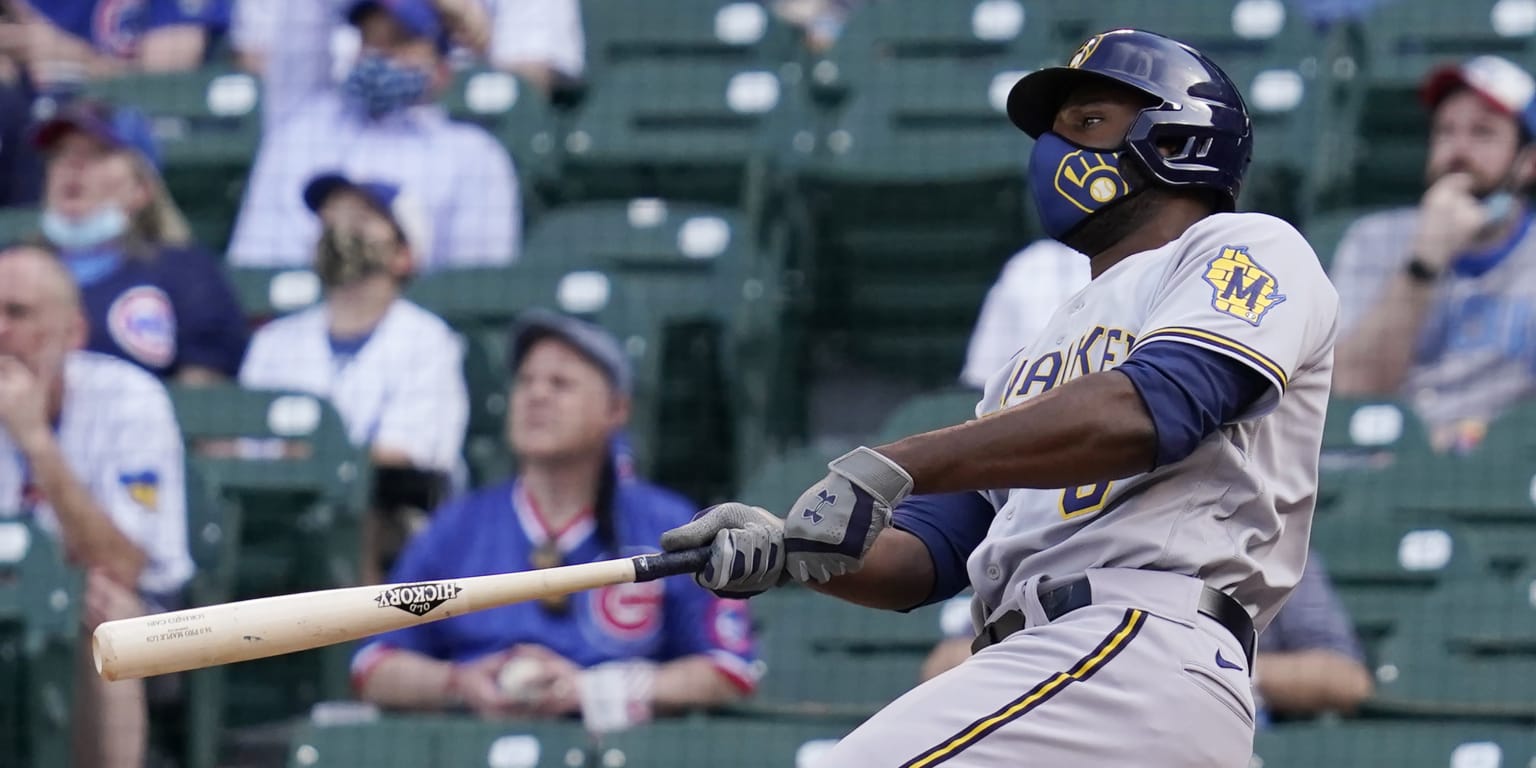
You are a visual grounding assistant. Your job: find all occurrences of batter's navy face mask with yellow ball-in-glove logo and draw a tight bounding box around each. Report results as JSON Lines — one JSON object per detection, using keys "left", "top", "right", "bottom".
{"left": 1029, "top": 131, "right": 1132, "bottom": 240}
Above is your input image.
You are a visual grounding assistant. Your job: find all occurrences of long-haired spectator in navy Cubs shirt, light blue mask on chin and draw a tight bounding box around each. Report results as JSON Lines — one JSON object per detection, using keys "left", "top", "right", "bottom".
{"left": 34, "top": 100, "right": 246, "bottom": 384}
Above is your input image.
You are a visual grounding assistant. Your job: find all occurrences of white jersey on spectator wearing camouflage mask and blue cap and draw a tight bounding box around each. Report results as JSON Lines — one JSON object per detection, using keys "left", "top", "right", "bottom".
{"left": 240, "top": 298, "right": 468, "bottom": 472}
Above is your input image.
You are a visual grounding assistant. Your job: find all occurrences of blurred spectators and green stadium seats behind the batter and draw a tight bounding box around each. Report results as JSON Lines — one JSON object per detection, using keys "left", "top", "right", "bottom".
{"left": 0, "top": 0, "right": 1536, "bottom": 768}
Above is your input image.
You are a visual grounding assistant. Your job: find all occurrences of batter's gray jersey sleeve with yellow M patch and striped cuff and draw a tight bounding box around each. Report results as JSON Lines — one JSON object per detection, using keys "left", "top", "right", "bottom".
{"left": 1132, "top": 217, "right": 1338, "bottom": 416}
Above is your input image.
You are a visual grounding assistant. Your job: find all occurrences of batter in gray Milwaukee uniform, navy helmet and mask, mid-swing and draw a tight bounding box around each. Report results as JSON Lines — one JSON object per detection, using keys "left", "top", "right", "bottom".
{"left": 662, "top": 29, "right": 1338, "bottom": 768}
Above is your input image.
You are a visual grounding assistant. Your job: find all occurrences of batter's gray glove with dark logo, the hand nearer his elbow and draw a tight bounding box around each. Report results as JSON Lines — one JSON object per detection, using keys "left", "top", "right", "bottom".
{"left": 783, "top": 447, "right": 912, "bottom": 582}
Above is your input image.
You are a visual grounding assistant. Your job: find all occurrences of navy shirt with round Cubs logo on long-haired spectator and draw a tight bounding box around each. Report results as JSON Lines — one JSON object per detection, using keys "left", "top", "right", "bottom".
{"left": 65, "top": 246, "right": 246, "bottom": 378}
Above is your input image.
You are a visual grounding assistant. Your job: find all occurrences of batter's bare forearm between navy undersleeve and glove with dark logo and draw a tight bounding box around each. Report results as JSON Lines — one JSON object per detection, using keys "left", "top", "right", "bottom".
{"left": 877, "top": 370, "right": 1157, "bottom": 493}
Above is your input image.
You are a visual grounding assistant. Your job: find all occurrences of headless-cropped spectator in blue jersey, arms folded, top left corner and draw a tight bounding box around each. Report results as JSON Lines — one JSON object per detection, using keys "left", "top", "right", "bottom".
{"left": 0, "top": 0, "right": 217, "bottom": 91}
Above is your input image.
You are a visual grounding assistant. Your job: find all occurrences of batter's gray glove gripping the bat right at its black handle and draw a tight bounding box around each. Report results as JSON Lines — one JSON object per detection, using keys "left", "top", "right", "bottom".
{"left": 662, "top": 502, "right": 786, "bottom": 599}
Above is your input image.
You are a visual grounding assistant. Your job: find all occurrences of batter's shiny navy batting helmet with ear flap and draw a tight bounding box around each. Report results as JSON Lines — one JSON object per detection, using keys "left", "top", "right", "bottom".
{"left": 1008, "top": 29, "right": 1253, "bottom": 210}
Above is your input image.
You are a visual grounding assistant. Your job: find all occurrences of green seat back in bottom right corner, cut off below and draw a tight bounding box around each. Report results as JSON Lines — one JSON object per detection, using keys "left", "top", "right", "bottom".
{"left": 1249, "top": 720, "right": 1536, "bottom": 768}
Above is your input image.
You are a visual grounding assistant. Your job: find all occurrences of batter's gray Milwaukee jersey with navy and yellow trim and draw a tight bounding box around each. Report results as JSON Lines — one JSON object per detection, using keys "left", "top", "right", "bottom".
{"left": 966, "top": 214, "right": 1338, "bottom": 628}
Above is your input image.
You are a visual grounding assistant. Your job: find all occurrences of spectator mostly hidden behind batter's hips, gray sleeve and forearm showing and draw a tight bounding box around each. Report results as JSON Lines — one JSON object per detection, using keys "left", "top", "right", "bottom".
{"left": 922, "top": 551, "right": 1372, "bottom": 720}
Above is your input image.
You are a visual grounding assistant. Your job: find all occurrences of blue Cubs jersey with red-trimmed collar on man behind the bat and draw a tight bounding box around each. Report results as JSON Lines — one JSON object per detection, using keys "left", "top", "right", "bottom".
{"left": 353, "top": 479, "right": 759, "bottom": 690}
